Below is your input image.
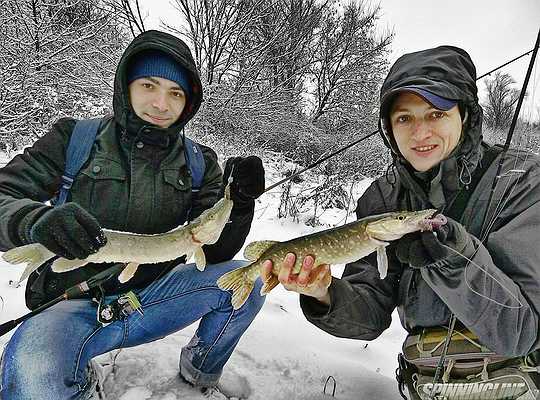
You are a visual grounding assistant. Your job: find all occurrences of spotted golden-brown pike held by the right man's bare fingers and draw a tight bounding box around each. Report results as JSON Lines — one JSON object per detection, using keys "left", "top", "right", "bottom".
{"left": 217, "top": 209, "right": 446, "bottom": 310}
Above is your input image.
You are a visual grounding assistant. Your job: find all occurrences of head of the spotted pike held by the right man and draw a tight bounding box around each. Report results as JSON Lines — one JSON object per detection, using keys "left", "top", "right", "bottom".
{"left": 366, "top": 209, "right": 437, "bottom": 242}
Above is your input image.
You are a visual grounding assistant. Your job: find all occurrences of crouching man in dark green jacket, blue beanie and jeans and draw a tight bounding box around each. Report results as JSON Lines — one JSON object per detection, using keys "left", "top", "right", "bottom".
{"left": 0, "top": 31, "right": 264, "bottom": 400}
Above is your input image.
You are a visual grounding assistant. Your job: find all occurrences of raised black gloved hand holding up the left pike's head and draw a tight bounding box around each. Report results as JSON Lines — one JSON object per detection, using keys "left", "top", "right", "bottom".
{"left": 223, "top": 156, "right": 264, "bottom": 205}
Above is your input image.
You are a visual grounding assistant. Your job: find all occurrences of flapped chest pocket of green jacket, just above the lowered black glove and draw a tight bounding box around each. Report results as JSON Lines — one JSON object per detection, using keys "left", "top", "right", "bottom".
{"left": 72, "top": 158, "right": 129, "bottom": 229}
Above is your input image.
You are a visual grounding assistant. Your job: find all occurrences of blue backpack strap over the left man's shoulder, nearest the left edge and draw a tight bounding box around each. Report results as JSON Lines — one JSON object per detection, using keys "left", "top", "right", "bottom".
{"left": 53, "top": 118, "right": 101, "bottom": 206}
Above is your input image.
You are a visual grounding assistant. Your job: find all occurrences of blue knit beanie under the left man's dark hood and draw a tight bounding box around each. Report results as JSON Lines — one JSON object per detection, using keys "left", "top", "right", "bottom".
{"left": 127, "top": 50, "right": 191, "bottom": 97}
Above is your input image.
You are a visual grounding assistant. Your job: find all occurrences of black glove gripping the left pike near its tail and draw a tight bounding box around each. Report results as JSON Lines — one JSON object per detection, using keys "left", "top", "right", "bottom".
{"left": 29, "top": 203, "right": 107, "bottom": 260}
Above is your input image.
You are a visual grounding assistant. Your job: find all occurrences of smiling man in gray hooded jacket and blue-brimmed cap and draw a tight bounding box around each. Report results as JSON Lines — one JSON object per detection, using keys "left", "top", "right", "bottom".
{"left": 263, "top": 46, "right": 540, "bottom": 396}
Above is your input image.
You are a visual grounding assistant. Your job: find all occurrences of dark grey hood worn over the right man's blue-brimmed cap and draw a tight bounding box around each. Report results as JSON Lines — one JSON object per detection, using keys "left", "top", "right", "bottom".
{"left": 379, "top": 46, "right": 483, "bottom": 190}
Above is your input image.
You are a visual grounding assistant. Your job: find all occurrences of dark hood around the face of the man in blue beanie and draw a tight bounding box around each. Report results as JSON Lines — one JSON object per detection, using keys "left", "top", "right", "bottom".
{"left": 113, "top": 30, "right": 203, "bottom": 142}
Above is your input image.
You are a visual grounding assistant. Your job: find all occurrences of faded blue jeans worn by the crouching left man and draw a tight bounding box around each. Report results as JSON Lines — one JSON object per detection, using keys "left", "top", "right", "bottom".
{"left": 0, "top": 261, "right": 264, "bottom": 400}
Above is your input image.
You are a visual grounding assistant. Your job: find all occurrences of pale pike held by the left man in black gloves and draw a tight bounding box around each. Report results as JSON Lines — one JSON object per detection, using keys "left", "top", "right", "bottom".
{"left": 2, "top": 185, "right": 233, "bottom": 283}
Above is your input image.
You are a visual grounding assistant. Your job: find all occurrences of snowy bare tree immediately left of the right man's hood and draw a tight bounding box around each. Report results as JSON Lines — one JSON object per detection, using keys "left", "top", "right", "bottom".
{"left": 307, "top": 1, "right": 393, "bottom": 175}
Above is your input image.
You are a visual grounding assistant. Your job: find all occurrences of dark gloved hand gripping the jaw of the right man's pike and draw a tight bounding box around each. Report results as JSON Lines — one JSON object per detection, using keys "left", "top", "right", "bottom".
{"left": 396, "top": 218, "right": 475, "bottom": 268}
